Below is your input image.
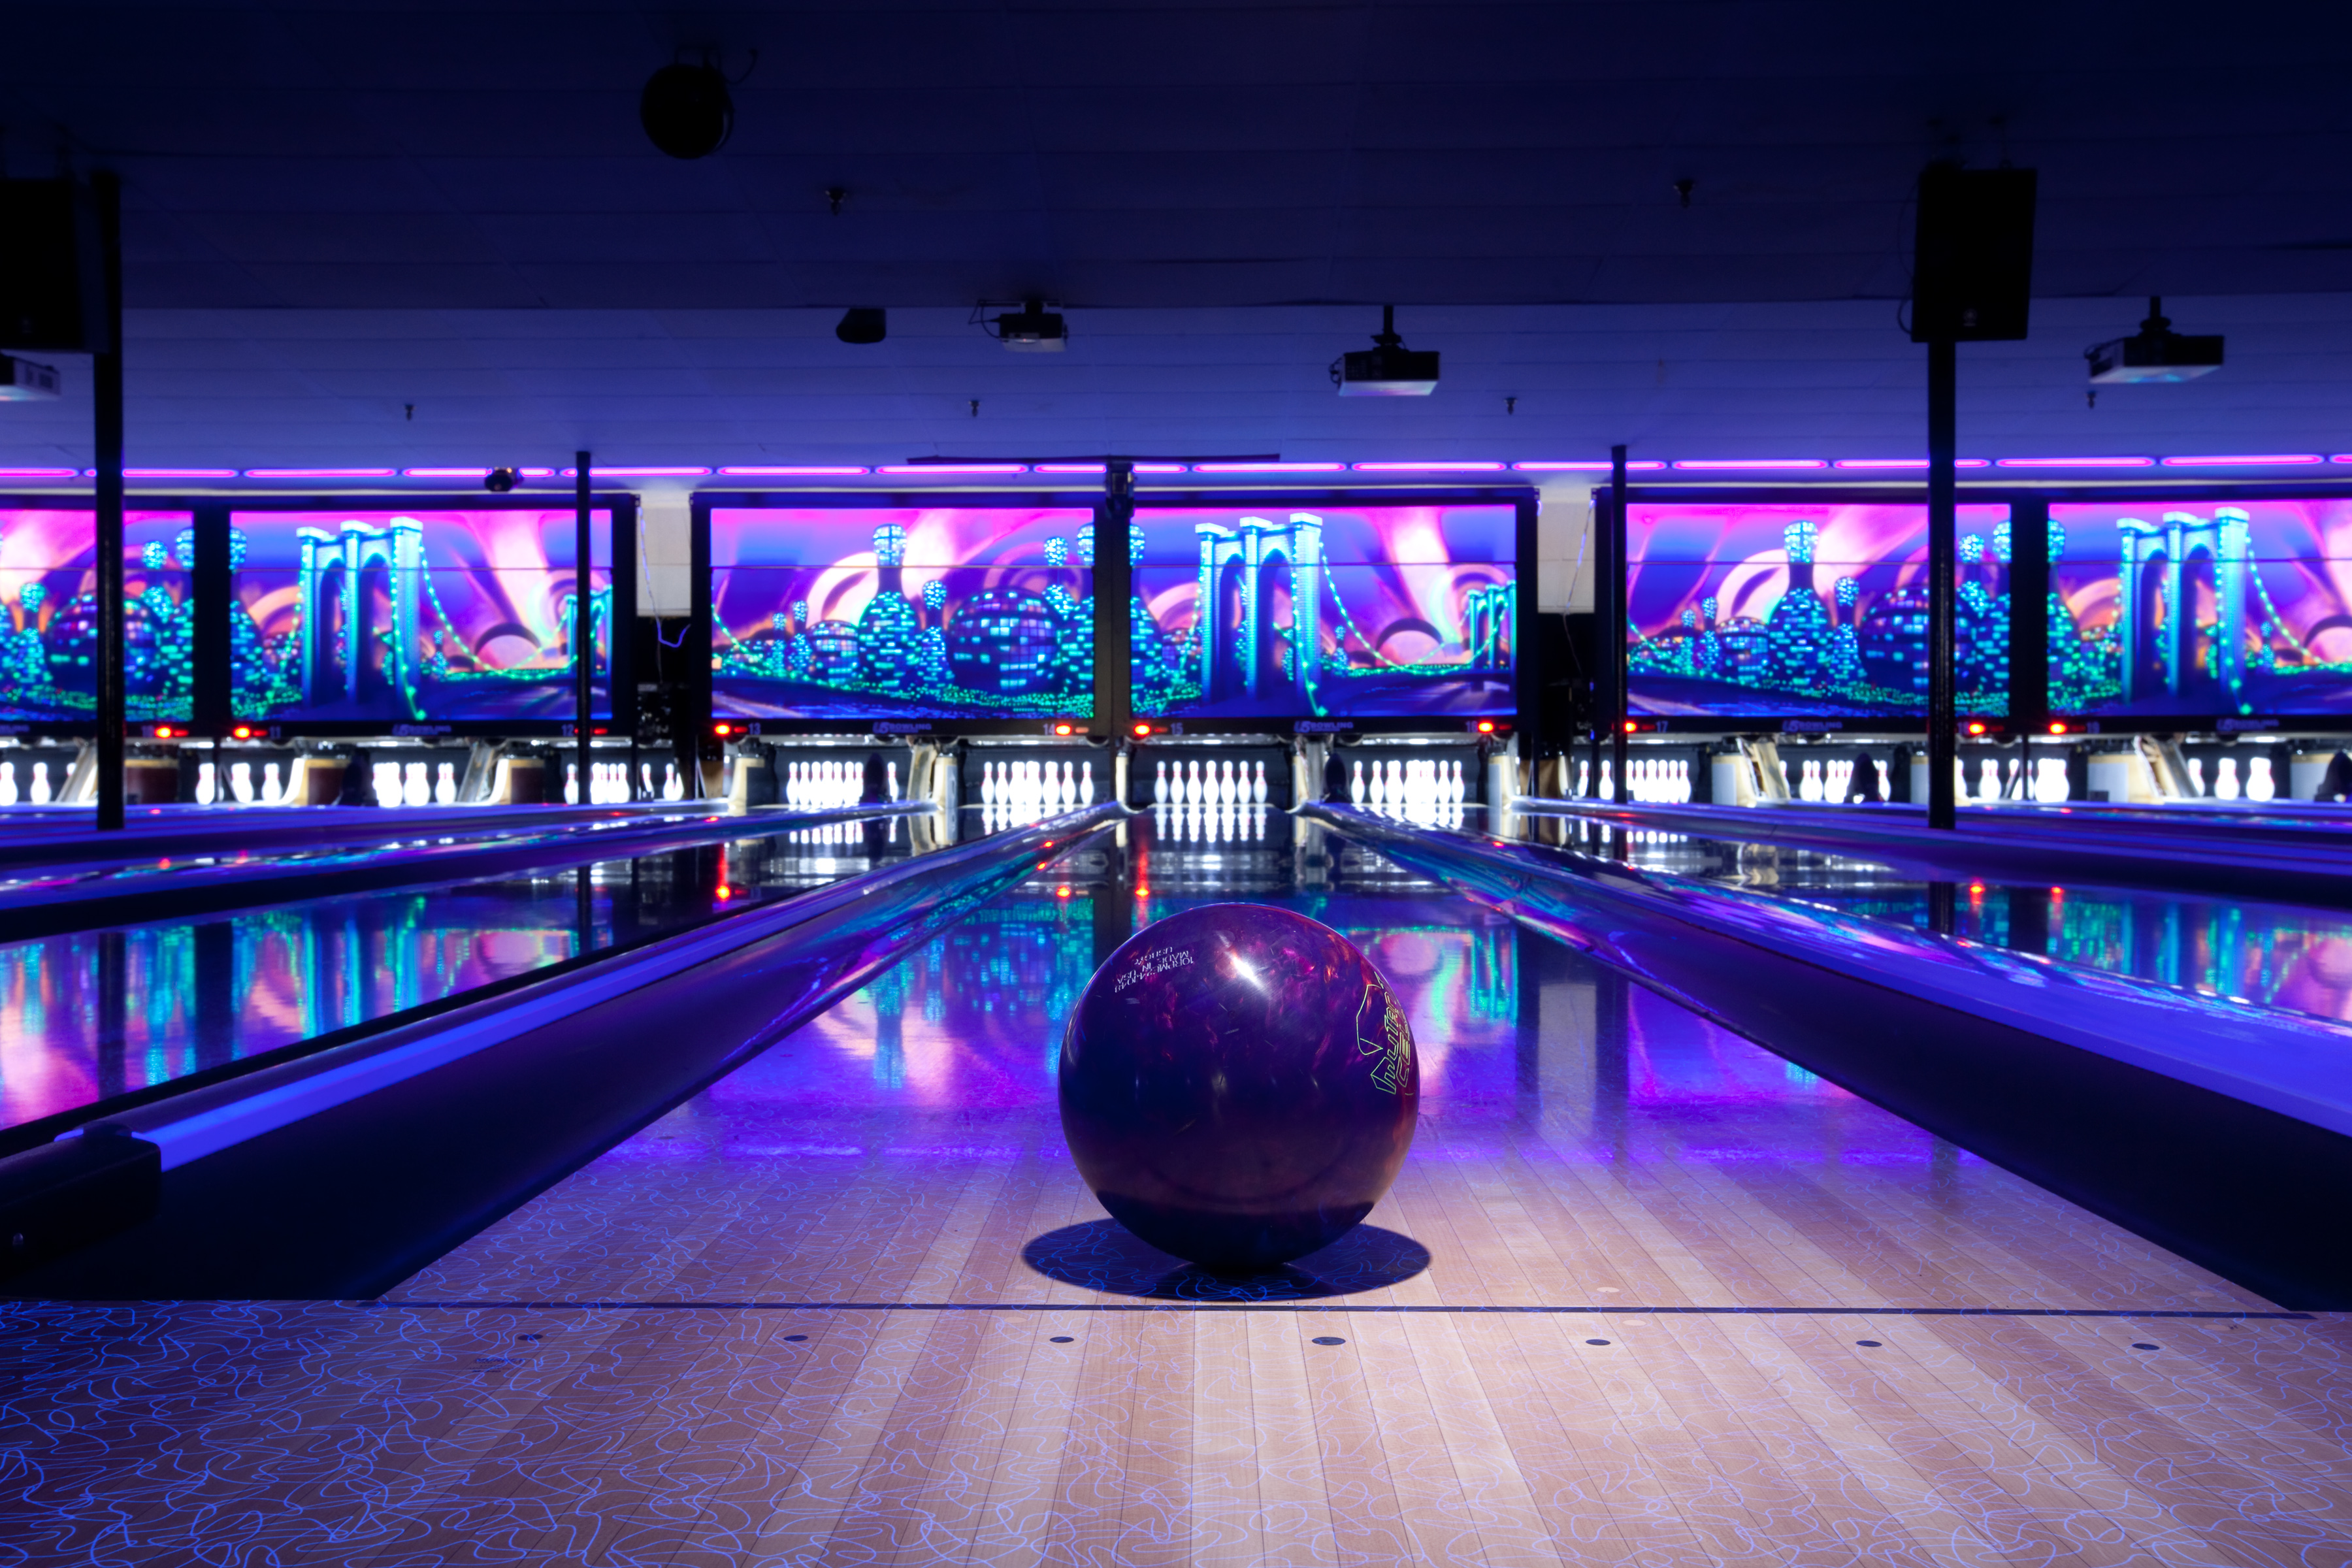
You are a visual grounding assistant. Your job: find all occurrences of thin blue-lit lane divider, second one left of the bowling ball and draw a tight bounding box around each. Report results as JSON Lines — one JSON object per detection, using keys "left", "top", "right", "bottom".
{"left": 0, "top": 802, "right": 932, "bottom": 943}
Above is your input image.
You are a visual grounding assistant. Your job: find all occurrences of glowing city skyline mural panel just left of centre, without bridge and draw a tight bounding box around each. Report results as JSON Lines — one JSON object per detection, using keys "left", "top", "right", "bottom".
{"left": 710, "top": 506, "right": 1094, "bottom": 719}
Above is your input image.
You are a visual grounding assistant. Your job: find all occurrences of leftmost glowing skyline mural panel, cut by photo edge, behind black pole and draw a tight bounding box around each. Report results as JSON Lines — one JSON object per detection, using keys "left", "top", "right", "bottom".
{"left": 0, "top": 508, "right": 195, "bottom": 724}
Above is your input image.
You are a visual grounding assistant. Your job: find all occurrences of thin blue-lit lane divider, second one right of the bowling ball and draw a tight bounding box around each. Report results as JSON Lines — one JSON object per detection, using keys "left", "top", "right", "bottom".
{"left": 1508, "top": 794, "right": 2352, "bottom": 907}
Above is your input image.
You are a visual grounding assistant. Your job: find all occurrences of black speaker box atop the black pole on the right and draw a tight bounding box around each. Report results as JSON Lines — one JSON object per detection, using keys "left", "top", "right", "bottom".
{"left": 1912, "top": 165, "right": 2034, "bottom": 343}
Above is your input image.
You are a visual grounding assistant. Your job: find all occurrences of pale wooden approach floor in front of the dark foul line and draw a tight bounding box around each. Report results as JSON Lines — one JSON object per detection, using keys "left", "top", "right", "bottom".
{"left": 0, "top": 1302, "right": 2352, "bottom": 1565}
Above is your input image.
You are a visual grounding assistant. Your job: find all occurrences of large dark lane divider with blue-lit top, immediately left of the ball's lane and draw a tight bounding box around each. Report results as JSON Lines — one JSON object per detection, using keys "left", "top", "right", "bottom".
{"left": 0, "top": 804, "right": 1126, "bottom": 1300}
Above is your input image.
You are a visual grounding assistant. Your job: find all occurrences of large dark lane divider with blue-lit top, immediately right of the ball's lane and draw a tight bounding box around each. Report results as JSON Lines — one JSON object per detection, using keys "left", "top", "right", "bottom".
{"left": 1301, "top": 806, "right": 2352, "bottom": 1309}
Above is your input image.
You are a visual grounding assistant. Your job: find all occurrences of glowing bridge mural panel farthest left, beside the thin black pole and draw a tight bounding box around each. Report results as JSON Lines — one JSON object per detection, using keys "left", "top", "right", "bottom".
{"left": 228, "top": 508, "right": 612, "bottom": 722}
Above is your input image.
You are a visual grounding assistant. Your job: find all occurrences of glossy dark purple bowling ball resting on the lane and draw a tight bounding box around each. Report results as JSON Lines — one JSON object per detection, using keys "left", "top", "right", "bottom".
{"left": 1061, "top": 903, "right": 1420, "bottom": 1272}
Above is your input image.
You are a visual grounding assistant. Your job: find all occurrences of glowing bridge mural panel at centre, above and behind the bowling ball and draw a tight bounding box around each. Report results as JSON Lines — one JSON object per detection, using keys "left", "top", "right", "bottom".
{"left": 1129, "top": 506, "right": 1520, "bottom": 717}
